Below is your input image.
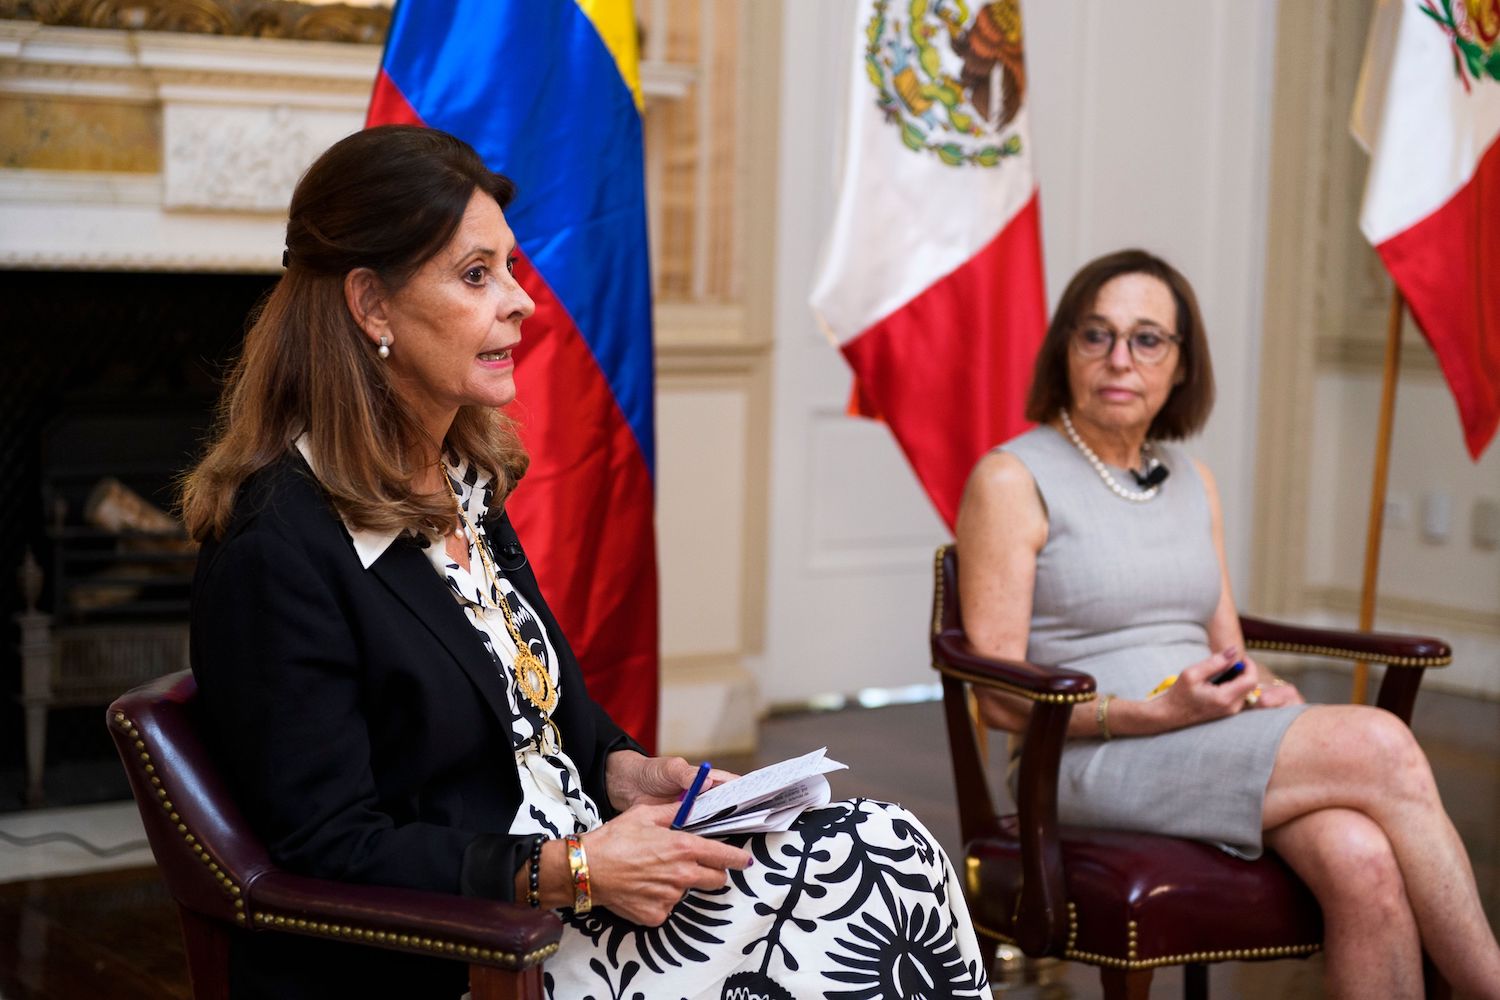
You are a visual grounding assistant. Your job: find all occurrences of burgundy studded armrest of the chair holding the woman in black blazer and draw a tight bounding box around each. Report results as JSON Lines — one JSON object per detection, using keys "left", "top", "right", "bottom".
{"left": 245, "top": 871, "right": 563, "bottom": 970}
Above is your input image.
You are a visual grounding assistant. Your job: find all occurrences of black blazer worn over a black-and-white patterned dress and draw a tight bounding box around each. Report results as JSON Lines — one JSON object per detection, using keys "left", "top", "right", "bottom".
{"left": 192, "top": 453, "right": 639, "bottom": 997}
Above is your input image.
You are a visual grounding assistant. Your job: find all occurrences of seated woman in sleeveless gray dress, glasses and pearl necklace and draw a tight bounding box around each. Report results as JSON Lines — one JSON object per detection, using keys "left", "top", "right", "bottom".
{"left": 957, "top": 250, "right": 1500, "bottom": 997}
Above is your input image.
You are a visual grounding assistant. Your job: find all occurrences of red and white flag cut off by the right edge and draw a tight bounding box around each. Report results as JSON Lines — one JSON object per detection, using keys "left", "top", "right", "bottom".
{"left": 1352, "top": 0, "right": 1500, "bottom": 460}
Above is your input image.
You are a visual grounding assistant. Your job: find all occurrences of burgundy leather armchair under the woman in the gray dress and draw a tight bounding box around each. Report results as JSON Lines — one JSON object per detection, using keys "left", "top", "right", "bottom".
{"left": 932, "top": 546, "right": 1452, "bottom": 1000}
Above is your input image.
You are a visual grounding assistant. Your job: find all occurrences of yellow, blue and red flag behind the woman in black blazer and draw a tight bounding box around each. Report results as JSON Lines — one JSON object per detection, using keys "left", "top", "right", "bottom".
{"left": 366, "top": 0, "right": 659, "bottom": 748}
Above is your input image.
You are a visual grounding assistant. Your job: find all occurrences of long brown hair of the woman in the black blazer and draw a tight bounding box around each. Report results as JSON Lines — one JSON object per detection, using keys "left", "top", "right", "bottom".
{"left": 180, "top": 124, "right": 527, "bottom": 541}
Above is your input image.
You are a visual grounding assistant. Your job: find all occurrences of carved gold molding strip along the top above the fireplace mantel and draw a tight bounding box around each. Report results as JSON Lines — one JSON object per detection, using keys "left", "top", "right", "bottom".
{"left": 0, "top": 0, "right": 390, "bottom": 45}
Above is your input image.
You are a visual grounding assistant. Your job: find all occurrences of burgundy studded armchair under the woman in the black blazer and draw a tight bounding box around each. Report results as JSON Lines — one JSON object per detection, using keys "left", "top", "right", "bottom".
{"left": 107, "top": 670, "right": 563, "bottom": 1000}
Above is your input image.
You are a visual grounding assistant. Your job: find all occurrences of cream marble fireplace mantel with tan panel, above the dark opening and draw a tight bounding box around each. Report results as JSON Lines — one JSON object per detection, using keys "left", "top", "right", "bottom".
{"left": 0, "top": 19, "right": 692, "bottom": 273}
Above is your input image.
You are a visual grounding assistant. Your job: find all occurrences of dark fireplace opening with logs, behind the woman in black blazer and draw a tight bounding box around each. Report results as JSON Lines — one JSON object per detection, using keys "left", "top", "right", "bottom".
{"left": 0, "top": 270, "right": 275, "bottom": 811}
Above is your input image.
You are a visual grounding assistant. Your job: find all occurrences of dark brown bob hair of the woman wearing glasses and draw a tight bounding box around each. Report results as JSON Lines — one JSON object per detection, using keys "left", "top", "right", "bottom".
{"left": 1026, "top": 250, "right": 1214, "bottom": 441}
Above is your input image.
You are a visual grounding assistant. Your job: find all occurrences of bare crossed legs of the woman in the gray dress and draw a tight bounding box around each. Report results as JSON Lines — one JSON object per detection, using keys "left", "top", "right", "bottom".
{"left": 1265, "top": 705, "right": 1500, "bottom": 1000}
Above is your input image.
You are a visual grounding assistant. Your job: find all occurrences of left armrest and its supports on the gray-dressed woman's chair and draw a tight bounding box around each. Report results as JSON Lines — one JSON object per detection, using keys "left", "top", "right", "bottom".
{"left": 932, "top": 631, "right": 1095, "bottom": 955}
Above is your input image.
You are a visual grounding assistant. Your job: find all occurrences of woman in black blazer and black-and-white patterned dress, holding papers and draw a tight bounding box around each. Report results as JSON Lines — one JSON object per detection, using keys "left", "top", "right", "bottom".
{"left": 182, "top": 126, "right": 986, "bottom": 999}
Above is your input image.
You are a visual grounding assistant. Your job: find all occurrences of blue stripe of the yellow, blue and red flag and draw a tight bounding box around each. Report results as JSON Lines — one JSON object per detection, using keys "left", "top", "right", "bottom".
{"left": 384, "top": 0, "right": 656, "bottom": 477}
